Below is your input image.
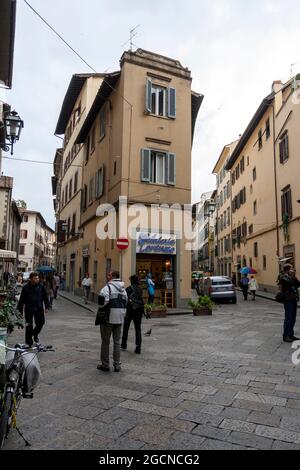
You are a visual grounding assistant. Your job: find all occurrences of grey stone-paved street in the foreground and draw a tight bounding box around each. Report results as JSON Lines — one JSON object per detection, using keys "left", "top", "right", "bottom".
{"left": 4, "top": 298, "right": 300, "bottom": 450}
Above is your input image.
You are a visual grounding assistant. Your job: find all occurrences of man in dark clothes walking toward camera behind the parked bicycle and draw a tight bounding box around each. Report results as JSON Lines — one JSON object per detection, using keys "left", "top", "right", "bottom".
{"left": 18, "top": 273, "right": 49, "bottom": 347}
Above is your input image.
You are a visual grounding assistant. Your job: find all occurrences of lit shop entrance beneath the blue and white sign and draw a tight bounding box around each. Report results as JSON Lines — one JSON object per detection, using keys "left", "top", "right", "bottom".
{"left": 136, "top": 253, "right": 176, "bottom": 308}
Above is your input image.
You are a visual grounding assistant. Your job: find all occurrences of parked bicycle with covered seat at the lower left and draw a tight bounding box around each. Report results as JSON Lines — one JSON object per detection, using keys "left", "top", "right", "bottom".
{"left": 0, "top": 344, "right": 54, "bottom": 449}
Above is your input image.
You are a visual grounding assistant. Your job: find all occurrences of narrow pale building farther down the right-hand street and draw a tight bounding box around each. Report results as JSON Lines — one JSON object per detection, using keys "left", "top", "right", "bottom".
{"left": 213, "top": 141, "right": 238, "bottom": 277}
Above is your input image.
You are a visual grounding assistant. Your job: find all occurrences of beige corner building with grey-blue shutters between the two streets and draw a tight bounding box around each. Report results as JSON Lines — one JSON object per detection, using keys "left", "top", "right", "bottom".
{"left": 54, "top": 49, "right": 203, "bottom": 306}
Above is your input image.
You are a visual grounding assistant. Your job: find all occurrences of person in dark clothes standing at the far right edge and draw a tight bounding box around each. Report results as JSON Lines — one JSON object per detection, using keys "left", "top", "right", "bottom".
{"left": 278, "top": 264, "right": 300, "bottom": 343}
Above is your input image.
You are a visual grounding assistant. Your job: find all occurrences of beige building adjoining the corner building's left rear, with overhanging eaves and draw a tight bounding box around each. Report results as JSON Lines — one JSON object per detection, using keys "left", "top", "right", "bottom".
{"left": 52, "top": 74, "right": 104, "bottom": 291}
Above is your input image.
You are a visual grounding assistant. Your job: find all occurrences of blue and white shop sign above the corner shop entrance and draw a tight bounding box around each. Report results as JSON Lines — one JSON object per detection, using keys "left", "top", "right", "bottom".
{"left": 136, "top": 232, "right": 176, "bottom": 255}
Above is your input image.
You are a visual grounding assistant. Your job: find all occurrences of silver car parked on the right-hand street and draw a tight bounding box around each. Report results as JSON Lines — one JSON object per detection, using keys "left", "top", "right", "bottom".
{"left": 197, "top": 276, "right": 237, "bottom": 304}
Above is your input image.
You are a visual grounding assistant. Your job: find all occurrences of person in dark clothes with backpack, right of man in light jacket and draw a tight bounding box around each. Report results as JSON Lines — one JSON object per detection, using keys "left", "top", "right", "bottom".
{"left": 121, "top": 275, "right": 144, "bottom": 354}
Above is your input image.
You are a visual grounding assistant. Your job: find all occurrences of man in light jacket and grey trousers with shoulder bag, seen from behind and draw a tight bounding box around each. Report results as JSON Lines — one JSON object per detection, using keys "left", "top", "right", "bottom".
{"left": 97, "top": 271, "right": 127, "bottom": 372}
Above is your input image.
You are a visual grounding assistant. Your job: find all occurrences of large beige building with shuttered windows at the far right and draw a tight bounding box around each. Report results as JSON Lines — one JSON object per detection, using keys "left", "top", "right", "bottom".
{"left": 227, "top": 77, "right": 300, "bottom": 291}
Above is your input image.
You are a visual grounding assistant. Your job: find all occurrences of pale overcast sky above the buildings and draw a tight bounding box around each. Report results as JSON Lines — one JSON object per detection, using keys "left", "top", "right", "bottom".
{"left": 0, "top": 0, "right": 300, "bottom": 226}
